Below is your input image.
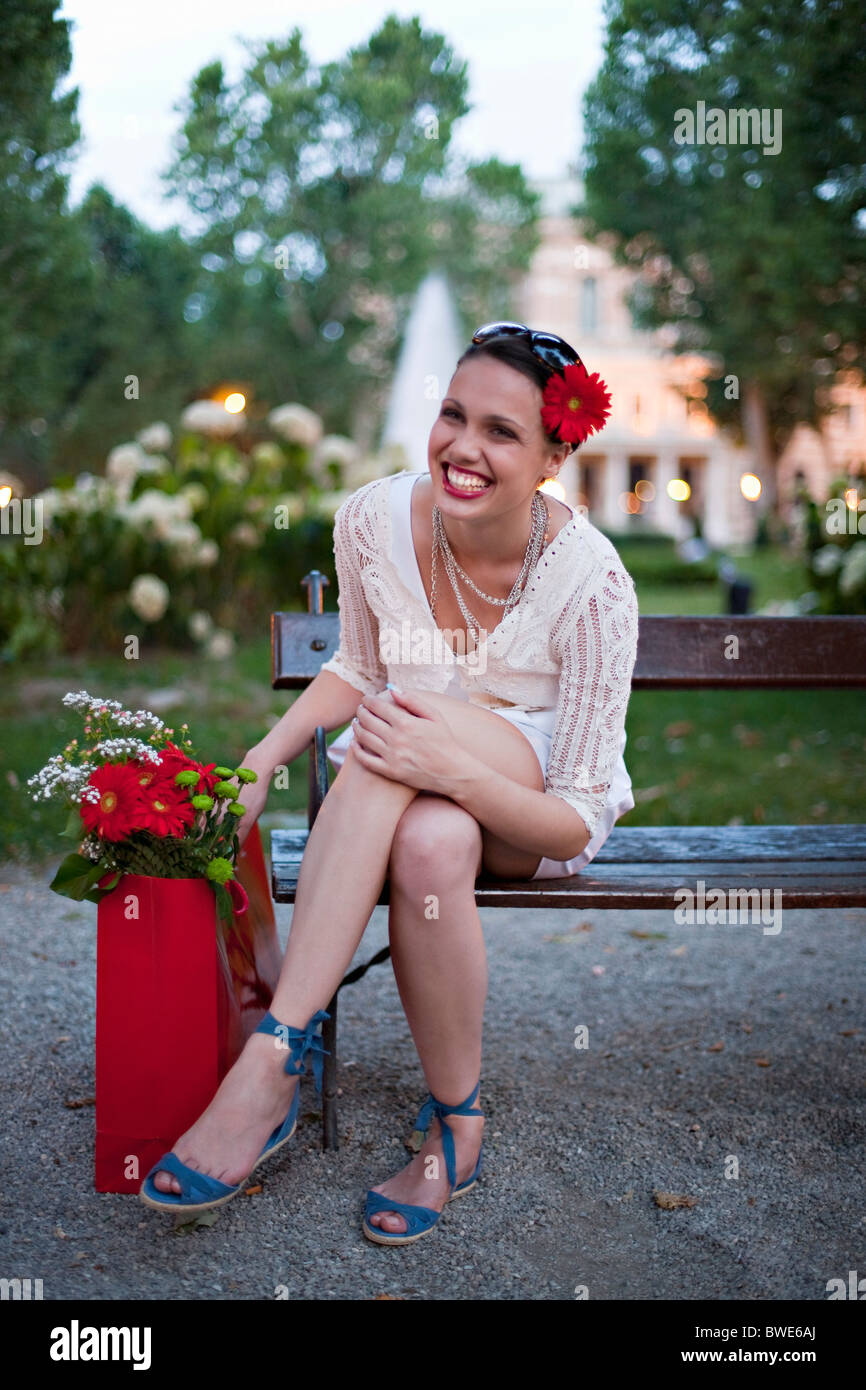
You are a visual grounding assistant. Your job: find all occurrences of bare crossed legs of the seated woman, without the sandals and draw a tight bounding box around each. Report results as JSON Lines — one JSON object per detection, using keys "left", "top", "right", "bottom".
{"left": 148, "top": 694, "right": 544, "bottom": 1206}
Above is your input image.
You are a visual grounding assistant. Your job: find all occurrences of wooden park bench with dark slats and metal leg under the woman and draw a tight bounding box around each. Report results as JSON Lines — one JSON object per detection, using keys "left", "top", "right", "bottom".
{"left": 271, "top": 570, "right": 866, "bottom": 1148}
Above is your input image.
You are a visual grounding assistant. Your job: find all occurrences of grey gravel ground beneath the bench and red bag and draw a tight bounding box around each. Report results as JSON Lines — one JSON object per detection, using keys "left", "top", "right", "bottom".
{"left": 0, "top": 866, "right": 866, "bottom": 1300}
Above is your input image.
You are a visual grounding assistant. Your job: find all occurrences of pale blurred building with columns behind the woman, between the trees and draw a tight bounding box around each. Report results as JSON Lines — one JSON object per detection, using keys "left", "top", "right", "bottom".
{"left": 518, "top": 179, "right": 866, "bottom": 545}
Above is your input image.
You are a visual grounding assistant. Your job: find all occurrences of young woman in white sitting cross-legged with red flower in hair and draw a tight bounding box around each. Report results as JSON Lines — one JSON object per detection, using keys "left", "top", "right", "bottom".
{"left": 142, "top": 324, "right": 638, "bottom": 1244}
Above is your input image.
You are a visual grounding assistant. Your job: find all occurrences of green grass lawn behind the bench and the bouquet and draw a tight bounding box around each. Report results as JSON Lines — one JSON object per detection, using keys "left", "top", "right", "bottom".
{"left": 0, "top": 539, "right": 866, "bottom": 862}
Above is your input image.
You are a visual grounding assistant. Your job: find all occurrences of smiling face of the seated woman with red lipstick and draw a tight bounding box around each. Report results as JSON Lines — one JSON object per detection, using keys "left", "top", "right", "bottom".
{"left": 427, "top": 356, "right": 570, "bottom": 517}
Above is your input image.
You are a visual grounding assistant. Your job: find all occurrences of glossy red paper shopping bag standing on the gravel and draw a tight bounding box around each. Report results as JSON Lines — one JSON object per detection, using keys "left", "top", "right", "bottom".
{"left": 95, "top": 826, "right": 281, "bottom": 1193}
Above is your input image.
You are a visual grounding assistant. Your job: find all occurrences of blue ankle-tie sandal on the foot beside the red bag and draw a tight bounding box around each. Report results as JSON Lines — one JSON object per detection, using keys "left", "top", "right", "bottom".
{"left": 139, "top": 1009, "right": 331, "bottom": 1212}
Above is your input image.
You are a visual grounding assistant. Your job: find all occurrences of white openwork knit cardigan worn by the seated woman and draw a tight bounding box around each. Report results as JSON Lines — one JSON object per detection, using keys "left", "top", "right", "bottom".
{"left": 315, "top": 468, "right": 638, "bottom": 835}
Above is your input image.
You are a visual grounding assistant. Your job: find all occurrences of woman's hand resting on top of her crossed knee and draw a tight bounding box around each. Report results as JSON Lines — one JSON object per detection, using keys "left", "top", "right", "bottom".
{"left": 352, "top": 689, "right": 466, "bottom": 796}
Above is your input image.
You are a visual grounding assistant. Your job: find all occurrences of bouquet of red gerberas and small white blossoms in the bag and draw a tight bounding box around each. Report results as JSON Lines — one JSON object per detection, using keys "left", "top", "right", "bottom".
{"left": 28, "top": 691, "right": 257, "bottom": 922}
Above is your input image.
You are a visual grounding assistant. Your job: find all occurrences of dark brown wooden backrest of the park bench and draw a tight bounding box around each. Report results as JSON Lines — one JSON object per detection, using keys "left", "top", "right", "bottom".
{"left": 271, "top": 570, "right": 866, "bottom": 689}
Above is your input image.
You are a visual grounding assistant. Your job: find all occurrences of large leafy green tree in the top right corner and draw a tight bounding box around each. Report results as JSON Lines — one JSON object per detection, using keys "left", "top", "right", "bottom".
{"left": 575, "top": 0, "right": 866, "bottom": 511}
